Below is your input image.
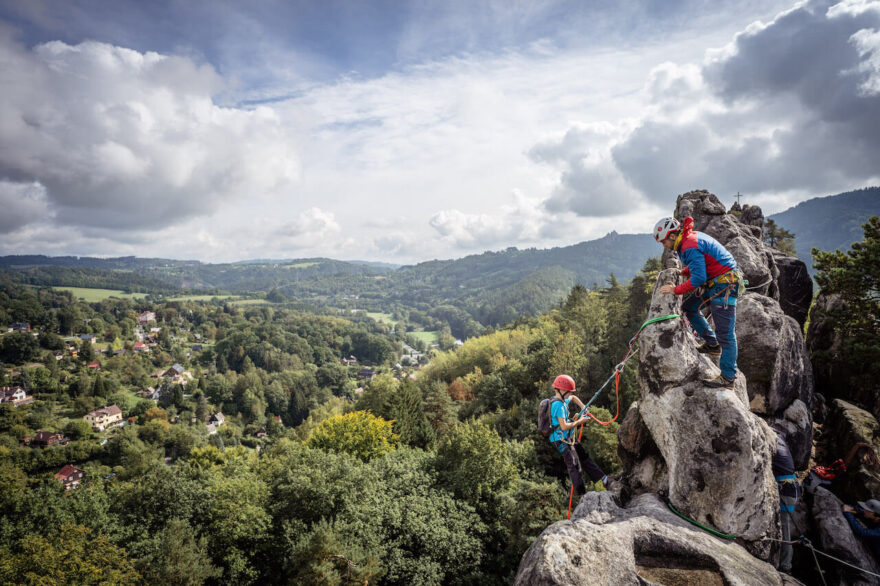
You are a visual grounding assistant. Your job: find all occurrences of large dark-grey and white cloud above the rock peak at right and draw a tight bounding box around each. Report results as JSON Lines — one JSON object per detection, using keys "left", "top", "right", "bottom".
{"left": 533, "top": 0, "right": 880, "bottom": 216}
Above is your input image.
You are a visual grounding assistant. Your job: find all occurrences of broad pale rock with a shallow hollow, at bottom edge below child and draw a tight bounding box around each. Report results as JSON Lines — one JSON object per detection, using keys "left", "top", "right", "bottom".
{"left": 514, "top": 492, "right": 785, "bottom": 586}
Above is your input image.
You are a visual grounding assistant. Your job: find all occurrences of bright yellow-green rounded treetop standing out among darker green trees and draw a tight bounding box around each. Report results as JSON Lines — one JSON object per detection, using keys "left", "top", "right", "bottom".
{"left": 306, "top": 411, "right": 399, "bottom": 461}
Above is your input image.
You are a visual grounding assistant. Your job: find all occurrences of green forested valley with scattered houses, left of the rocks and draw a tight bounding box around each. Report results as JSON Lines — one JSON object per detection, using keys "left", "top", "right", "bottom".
{"left": 0, "top": 261, "right": 657, "bottom": 584}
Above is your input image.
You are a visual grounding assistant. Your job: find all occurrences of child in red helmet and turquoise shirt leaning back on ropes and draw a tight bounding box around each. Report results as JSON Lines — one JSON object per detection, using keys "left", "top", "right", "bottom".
{"left": 550, "top": 374, "right": 608, "bottom": 496}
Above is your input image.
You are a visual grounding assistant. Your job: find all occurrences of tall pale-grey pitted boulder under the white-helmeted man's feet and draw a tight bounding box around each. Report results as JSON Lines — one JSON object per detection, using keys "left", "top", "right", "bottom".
{"left": 627, "top": 271, "right": 779, "bottom": 556}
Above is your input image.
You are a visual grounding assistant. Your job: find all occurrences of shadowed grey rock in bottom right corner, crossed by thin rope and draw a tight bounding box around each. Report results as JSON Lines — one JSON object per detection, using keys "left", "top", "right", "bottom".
{"left": 812, "top": 488, "right": 880, "bottom": 586}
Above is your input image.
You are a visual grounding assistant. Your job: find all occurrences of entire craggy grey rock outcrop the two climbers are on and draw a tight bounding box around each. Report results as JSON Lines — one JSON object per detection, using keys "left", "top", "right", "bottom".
{"left": 517, "top": 191, "right": 813, "bottom": 584}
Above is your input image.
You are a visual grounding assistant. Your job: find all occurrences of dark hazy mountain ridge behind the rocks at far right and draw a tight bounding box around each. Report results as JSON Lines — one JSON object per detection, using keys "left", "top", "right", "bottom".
{"left": 768, "top": 187, "right": 880, "bottom": 272}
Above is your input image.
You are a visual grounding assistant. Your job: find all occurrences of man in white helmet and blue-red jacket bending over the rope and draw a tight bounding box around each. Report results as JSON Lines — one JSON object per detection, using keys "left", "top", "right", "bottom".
{"left": 654, "top": 217, "right": 745, "bottom": 389}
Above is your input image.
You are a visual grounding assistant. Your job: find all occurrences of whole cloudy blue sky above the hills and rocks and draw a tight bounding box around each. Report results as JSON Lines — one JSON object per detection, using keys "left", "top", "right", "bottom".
{"left": 0, "top": 0, "right": 880, "bottom": 262}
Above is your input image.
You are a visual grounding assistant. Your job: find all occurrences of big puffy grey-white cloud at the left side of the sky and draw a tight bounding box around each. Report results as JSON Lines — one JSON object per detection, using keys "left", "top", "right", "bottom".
{"left": 0, "top": 34, "right": 299, "bottom": 229}
